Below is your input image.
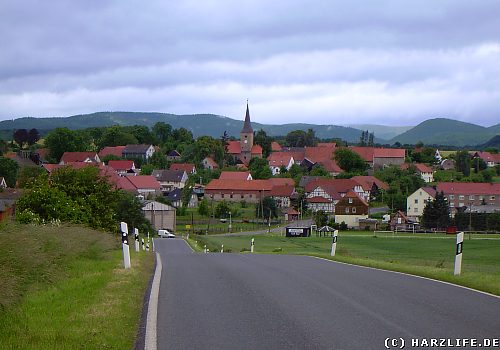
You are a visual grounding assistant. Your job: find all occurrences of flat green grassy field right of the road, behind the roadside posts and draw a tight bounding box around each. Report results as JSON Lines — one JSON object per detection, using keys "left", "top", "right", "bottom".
{"left": 190, "top": 232, "right": 500, "bottom": 295}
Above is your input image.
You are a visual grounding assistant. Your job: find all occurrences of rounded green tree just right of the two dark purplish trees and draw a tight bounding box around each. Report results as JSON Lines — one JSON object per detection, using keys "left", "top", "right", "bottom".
{"left": 45, "top": 128, "right": 90, "bottom": 162}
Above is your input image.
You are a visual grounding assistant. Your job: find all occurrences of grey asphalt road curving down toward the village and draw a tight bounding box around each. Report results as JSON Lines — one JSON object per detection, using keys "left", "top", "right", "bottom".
{"left": 155, "top": 239, "right": 500, "bottom": 350}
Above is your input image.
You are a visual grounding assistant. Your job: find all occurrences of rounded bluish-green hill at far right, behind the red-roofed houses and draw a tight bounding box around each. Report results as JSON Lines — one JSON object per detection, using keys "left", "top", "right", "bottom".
{"left": 390, "top": 118, "right": 500, "bottom": 147}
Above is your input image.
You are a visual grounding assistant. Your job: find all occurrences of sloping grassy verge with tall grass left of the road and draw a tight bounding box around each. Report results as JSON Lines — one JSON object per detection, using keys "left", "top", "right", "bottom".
{"left": 0, "top": 224, "right": 154, "bottom": 349}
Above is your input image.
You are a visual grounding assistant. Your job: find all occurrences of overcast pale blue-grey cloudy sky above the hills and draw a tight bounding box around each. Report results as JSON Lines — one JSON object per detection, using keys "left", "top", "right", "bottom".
{"left": 0, "top": 0, "right": 500, "bottom": 126}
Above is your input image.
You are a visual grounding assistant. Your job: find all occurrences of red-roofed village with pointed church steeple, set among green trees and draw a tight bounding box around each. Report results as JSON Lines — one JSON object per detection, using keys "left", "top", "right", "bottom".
{"left": 0, "top": 104, "right": 500, "bottom": 233}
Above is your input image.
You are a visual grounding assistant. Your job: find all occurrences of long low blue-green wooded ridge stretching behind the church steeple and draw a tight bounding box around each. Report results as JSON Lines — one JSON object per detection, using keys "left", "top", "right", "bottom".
{"left": 0, "top": 112, "right": 368, "bottom": 142}
